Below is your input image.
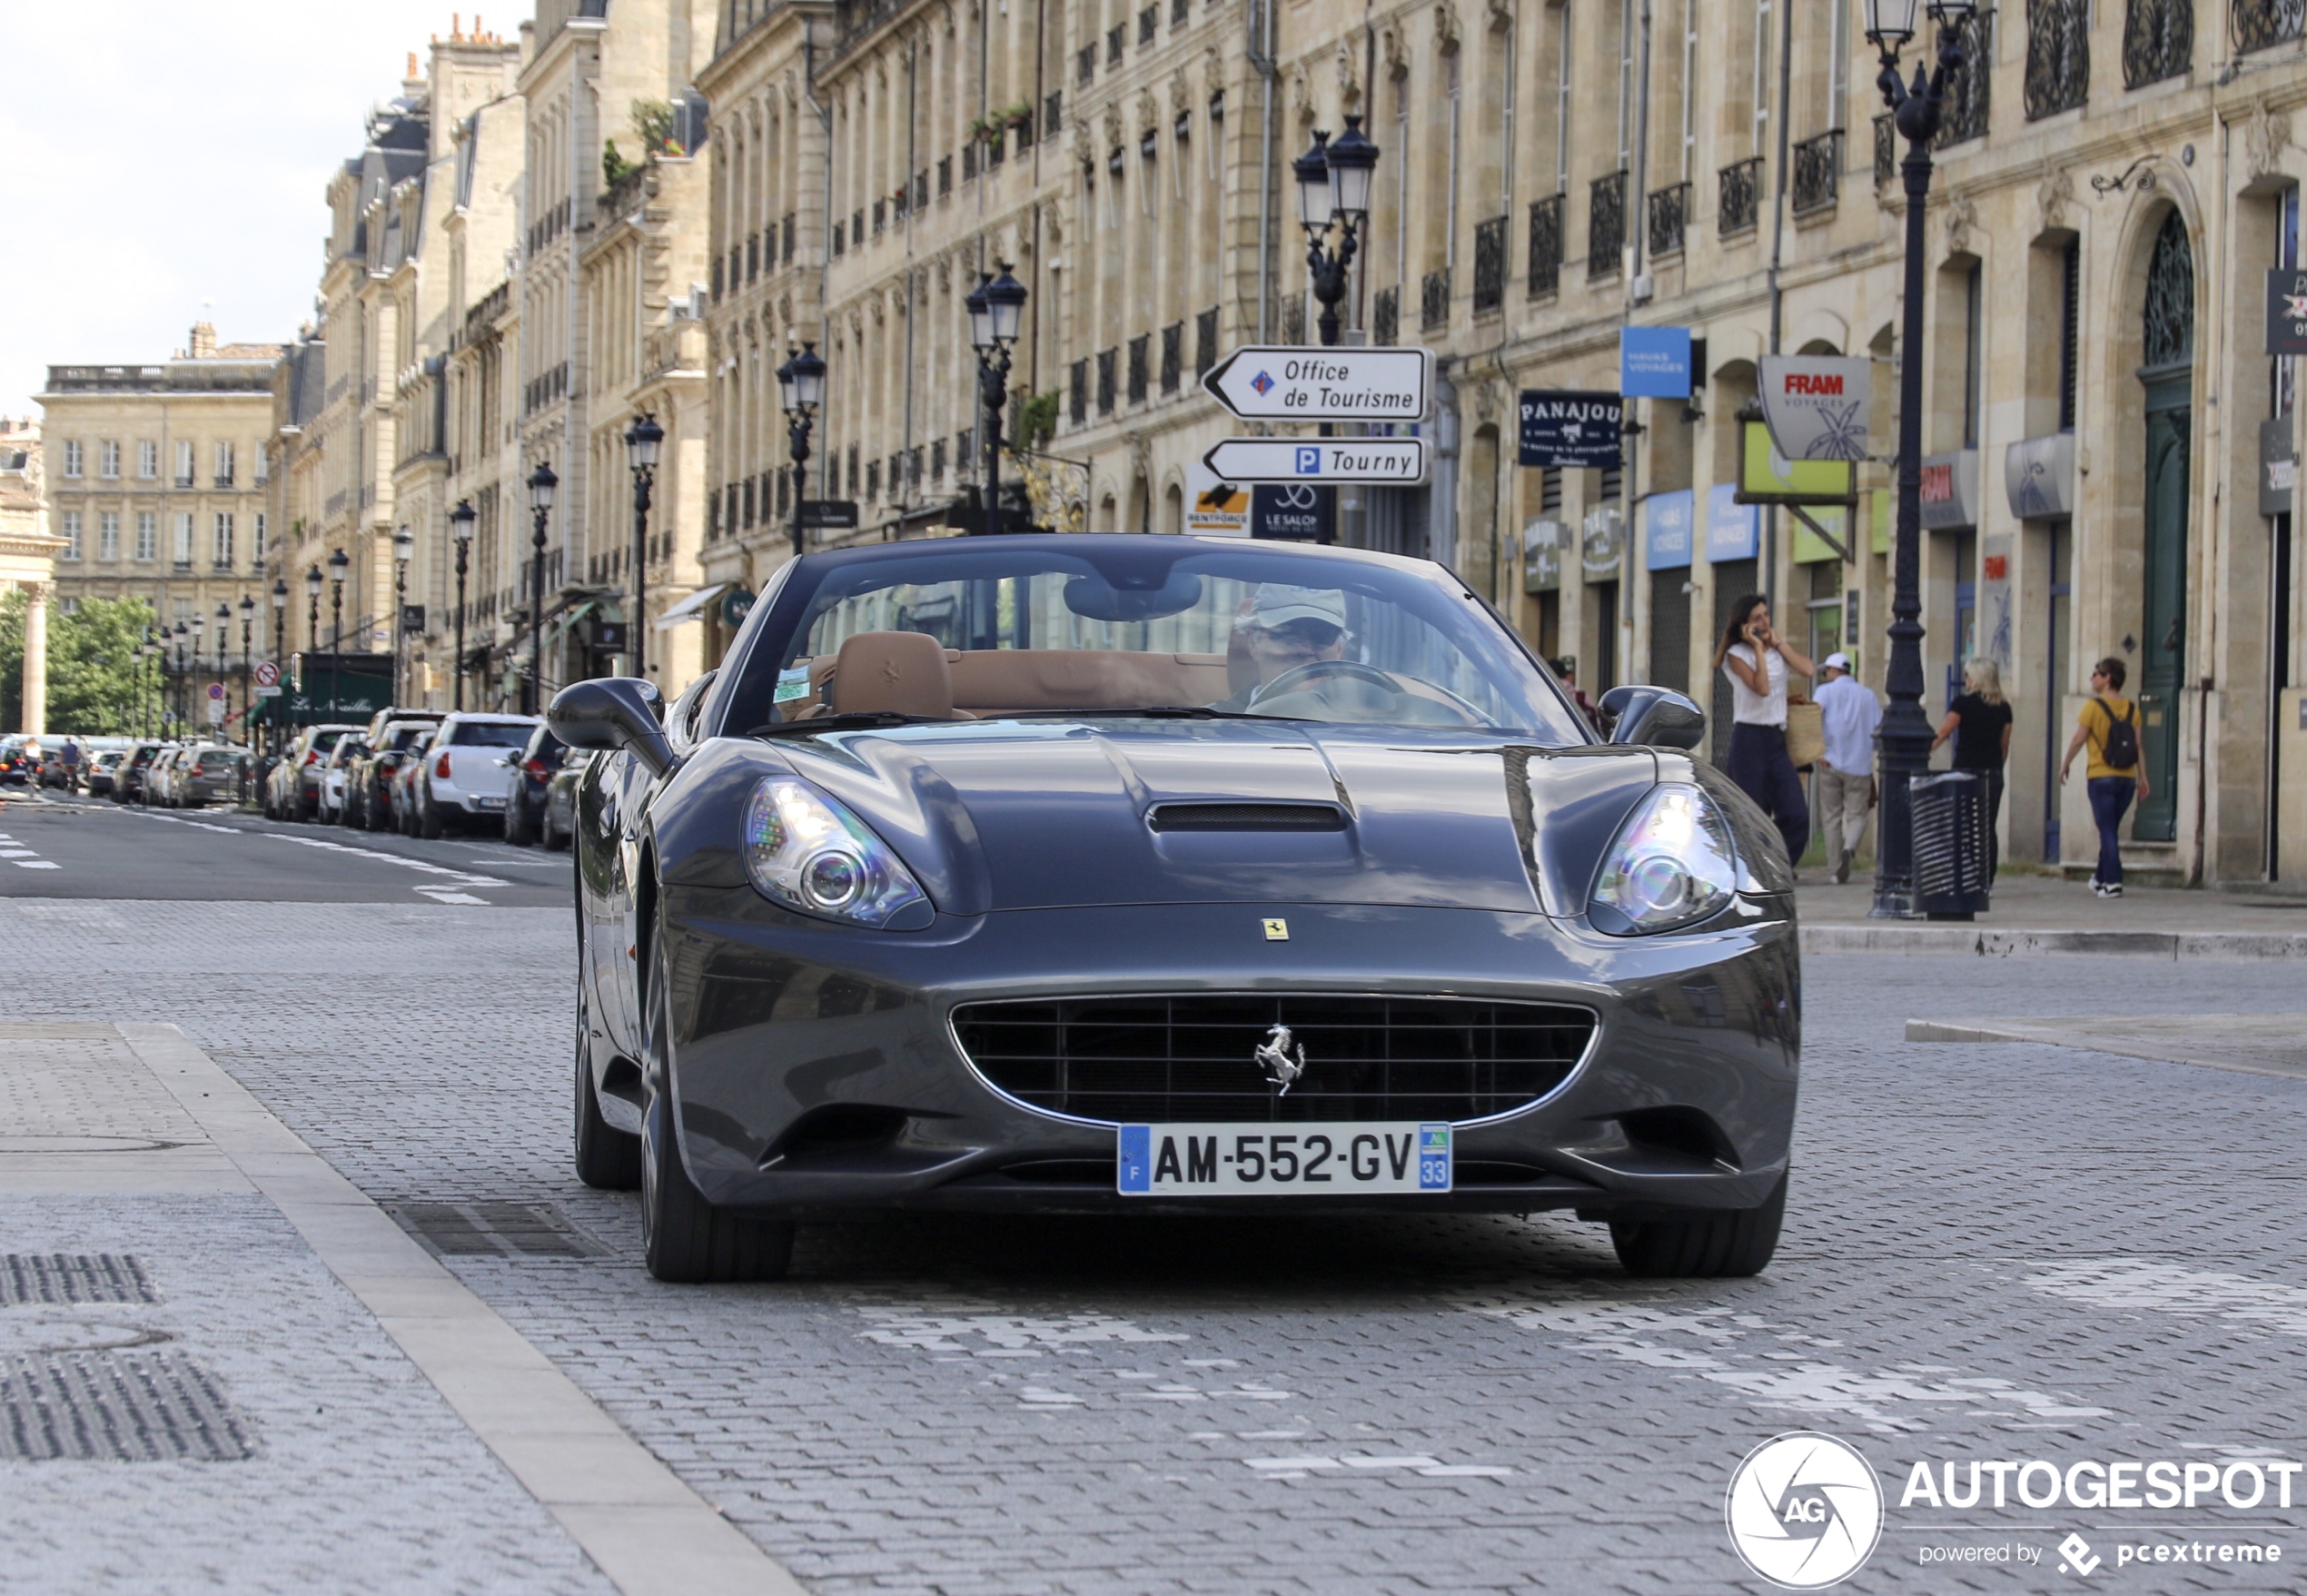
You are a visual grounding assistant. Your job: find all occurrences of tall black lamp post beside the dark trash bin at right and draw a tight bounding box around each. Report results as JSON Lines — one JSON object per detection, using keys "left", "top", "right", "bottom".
{"left": 1866, "top": 0, "right": 1975, "bottom": 920}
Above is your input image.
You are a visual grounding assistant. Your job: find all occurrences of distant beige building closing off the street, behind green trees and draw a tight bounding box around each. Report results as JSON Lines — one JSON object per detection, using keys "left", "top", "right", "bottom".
{"left": 39, "top": 336, "right": 282, "bottom": 724}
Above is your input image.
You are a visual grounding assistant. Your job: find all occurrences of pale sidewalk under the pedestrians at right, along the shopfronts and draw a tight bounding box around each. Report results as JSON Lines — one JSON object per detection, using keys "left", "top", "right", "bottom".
{"left": 1795, "top": 867, "right": 2307, "bottom": 959}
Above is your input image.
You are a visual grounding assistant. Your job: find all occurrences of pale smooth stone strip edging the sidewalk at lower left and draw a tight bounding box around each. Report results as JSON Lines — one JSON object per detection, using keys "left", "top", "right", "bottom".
{"left": 118, "top": 1024, "right": 803, "bottom": 1596}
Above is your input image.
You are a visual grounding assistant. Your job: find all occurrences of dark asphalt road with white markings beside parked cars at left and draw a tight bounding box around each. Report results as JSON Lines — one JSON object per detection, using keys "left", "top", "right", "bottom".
{"left": 0, "top": 787, "right": 569, "bottom": 908}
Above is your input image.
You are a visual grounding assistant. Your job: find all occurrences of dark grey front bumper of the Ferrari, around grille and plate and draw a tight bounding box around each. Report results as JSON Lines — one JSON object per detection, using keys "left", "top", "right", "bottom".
{"left": 650, "top": 886, "right": 1799, "bottom": 1218}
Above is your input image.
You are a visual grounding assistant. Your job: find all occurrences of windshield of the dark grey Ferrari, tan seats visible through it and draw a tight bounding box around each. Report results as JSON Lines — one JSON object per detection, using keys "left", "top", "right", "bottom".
{"left": 722, "top": 538, "right": 1589, "bottom": 745}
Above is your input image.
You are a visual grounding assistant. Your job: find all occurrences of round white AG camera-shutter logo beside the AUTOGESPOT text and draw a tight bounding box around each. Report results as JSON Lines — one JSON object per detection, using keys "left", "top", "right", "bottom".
{"left": 1723, "top": 1430, "right": 1883, "bottom": 1591}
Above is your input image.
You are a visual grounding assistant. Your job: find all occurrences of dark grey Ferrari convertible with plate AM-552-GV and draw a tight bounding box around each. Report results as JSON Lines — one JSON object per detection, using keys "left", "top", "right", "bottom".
{"left": 551, "top": 535, "right": 1799, "bottom": 1280}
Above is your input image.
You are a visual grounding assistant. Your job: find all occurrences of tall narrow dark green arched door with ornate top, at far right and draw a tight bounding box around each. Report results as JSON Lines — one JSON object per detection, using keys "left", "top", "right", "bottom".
{"left": 2132, "top": 210, "right": 2194, "bottom": 842}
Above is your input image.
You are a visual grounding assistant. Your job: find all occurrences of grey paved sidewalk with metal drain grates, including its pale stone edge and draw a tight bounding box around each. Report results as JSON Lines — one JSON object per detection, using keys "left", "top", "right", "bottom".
{"left": 0, "top": 1024, "right": 798, "bottom": 1596}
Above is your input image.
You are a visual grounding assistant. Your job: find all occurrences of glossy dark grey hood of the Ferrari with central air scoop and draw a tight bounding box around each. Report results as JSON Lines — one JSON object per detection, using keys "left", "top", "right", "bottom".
{"left": 697, "top": 718, "right": 1657, "bottom": 916}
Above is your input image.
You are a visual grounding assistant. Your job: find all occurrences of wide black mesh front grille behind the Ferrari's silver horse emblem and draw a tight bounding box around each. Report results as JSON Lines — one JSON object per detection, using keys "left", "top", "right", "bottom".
{"left": 953, "top": 992, "right": 1594, "bottom": 1124}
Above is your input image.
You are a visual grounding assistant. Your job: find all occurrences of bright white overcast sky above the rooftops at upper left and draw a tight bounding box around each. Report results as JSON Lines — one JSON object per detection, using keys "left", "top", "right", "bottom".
{"left": 0, "top": 0, "right": 477, "bottom": 415}
